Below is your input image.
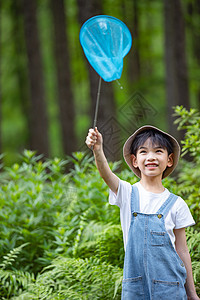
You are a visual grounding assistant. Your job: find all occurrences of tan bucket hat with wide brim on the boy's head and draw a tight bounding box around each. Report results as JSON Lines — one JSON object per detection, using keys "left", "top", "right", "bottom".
{"left": 123, "top": 125, "right": 181, "bottom": 178}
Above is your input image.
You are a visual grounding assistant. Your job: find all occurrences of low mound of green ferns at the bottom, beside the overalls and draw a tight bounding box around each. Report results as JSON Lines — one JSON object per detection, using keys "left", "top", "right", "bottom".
{"left": 13, "top": 257, "right": 122, "bottom": 300}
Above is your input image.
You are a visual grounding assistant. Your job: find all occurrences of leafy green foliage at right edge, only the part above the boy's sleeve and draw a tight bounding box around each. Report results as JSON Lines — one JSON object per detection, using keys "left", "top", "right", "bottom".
{"left": 175, "top": 106, "right": 200, "bottom": 229}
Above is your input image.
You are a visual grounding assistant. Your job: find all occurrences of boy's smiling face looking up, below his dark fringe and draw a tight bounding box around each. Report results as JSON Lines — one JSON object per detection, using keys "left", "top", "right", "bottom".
{"left": 131, "top": 139, "right": 173, "bottom": 179}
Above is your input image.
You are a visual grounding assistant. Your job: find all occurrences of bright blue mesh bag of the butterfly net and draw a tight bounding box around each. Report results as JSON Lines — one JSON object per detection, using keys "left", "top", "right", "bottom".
{"left": 80, "top": 15, "right": 132, "bottom": 81}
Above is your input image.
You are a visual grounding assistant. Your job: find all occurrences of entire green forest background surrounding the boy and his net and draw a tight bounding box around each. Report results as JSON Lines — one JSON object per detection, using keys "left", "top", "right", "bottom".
{"left": 0, "top": 0, "right": 200, "bottom": 300}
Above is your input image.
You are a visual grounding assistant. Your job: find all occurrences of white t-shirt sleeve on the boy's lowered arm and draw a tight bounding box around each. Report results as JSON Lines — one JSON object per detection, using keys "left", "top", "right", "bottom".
{"left": 175, "top": 197, "right": 195, "bottom": 229}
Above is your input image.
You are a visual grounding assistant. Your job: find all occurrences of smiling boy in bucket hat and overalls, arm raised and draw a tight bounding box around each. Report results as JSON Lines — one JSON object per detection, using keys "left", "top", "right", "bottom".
{"left": 86, "top": 126, "right": 199, "bottom": 300}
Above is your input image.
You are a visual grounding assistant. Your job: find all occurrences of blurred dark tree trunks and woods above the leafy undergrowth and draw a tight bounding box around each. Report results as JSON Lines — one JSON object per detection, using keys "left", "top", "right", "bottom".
{"left": 0, "top": 0, "right": 200, "bottom": 165}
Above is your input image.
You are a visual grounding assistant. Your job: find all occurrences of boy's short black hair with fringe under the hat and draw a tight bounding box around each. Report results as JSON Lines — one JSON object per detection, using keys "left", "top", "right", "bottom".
{"left": 130, "top": 129, "right": 173, "bottom": 156}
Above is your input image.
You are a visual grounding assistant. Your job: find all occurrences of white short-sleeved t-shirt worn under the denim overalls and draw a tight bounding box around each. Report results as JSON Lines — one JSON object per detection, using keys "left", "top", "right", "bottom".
{"left": 109, "top": 180, "right": 195, "bottom": 249}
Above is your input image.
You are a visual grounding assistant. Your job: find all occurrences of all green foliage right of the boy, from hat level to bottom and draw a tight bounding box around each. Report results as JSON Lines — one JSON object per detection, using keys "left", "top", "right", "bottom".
{"left": 175, "top": 106, "right": 200, "bottom": 294}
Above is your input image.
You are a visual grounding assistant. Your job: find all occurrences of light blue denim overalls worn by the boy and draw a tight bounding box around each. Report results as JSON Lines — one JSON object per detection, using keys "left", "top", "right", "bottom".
{"left": 122, "top": 186, "right": 187, "bottom": 300}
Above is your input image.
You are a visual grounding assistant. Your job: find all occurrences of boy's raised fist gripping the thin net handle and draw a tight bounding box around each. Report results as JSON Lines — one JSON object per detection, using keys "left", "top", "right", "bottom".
{"left": 85, "top": 127, "right": 103, "bottom": 151}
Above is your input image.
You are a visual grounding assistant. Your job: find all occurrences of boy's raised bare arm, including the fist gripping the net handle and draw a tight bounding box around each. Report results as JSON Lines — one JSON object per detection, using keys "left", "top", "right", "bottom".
{"left": 86, "top": 127, "right": 119, "bottom": 194}
